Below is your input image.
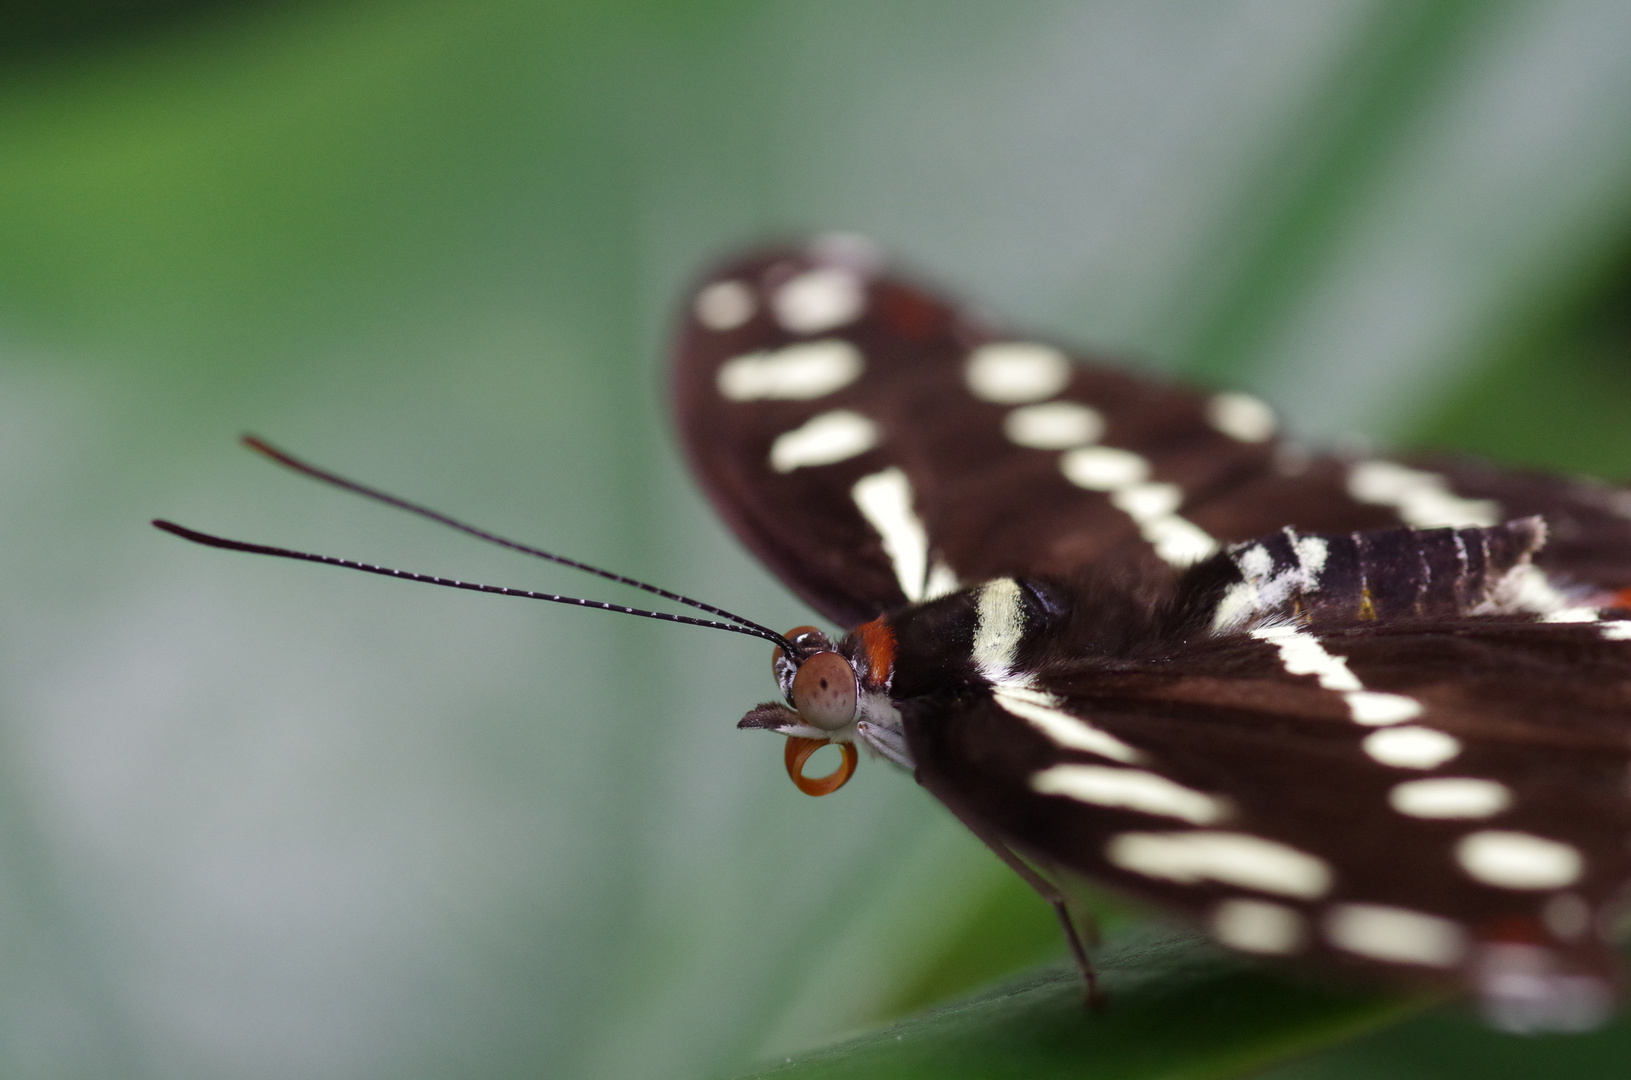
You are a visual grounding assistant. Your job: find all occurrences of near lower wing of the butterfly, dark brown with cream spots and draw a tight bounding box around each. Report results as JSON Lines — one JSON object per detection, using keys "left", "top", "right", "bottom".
{"left": 905, "top": 618, "right": 1631, "bottom": 1028}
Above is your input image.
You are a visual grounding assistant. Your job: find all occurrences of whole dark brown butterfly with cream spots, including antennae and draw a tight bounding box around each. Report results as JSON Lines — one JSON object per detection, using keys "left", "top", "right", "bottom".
{"left": 155, "top": 238, "right": 1631, "bottom": 1031}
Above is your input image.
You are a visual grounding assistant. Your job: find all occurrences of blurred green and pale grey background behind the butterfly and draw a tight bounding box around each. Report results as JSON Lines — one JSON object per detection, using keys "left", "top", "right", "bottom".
{"left": 9, "top": 0, "right": 1631, "bottom": 1080}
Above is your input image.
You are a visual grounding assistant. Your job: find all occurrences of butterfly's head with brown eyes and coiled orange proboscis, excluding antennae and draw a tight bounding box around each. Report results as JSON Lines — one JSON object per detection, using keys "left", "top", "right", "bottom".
{"left": 737, "top": 618, "right": 910, "bottom": 795}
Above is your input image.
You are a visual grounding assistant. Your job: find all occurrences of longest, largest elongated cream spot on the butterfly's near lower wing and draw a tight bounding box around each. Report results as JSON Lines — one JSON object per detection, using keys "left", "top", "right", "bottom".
{"left": 1104, "top": 830, "right": 1331, "bottom": 899}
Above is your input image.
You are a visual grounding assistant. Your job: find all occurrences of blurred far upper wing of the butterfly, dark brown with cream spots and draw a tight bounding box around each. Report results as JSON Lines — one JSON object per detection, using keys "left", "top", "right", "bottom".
{"left": 674, "top": 240, "right": 1631, "bottom": 626}
